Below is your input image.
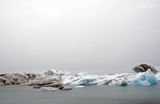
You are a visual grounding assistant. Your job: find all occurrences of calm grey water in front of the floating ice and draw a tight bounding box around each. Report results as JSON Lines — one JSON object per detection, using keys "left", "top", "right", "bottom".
{"left": 0, "top": 85, "right": 160, "bottom": 104}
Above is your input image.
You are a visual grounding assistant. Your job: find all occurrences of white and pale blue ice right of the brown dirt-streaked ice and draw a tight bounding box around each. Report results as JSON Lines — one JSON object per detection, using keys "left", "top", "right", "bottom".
{"left": 61, "top": 69, "right": 160, "bottom": 86}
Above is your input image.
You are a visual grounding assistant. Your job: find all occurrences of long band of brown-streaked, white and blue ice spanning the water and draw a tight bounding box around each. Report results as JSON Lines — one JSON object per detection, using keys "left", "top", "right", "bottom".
{"left": 0, "top": 68, "right": 160, "bottom": 90}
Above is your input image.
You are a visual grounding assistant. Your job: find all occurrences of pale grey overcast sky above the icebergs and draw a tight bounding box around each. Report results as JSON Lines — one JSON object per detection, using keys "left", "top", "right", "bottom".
{"left": 0, "top": 0, "right": 160, "bottom": 73}
